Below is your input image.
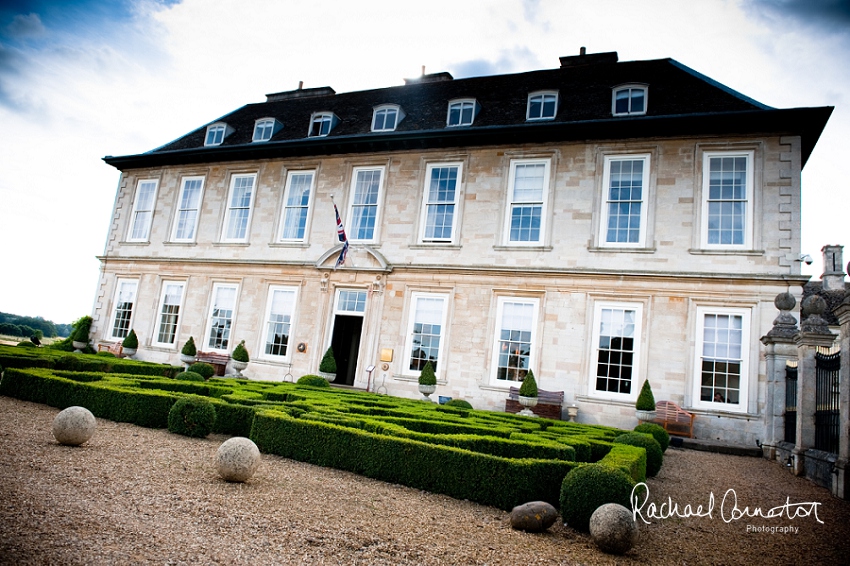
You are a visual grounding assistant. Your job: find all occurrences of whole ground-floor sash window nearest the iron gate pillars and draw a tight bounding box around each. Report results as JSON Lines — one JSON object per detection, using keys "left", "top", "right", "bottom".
{"left": 695, "top": 307, "right": 750, "bottom": 411}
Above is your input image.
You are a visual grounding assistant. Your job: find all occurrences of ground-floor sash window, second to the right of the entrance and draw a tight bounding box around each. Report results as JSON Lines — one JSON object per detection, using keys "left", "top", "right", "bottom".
{"left": 493, "top": 297, "right": 540, "bottom": 385}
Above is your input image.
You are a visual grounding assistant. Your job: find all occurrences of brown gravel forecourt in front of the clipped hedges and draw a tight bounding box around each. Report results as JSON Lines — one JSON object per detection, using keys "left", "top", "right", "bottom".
{"left": 0, "top": 396, "right": 850, "bottom": 565}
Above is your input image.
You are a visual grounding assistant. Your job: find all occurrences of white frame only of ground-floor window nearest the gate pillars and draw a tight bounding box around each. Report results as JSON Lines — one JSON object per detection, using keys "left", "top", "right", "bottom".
{"left": 692, "top": 305, "right": 753, "bottom": 413}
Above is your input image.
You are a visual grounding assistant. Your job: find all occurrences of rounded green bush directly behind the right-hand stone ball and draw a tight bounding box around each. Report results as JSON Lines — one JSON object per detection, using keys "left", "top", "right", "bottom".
{"left": 561, "top": 464, "right": 634, "bottom": 532}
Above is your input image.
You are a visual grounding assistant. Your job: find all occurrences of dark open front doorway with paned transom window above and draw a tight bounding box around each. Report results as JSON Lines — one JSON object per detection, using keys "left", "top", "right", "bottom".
{"left": 331, "top": 289, "right": 367, "bottom": 385}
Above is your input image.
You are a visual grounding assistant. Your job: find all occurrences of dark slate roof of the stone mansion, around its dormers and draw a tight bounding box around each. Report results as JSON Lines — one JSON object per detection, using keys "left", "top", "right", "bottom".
{"left": 104, "top": 53, "right": 832, "bottom": 169}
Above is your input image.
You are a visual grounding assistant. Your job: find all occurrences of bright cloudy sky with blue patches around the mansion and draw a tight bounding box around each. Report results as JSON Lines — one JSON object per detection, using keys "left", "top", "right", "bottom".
{"left": 0, "top": 0, "right": 850, "bottom": 322}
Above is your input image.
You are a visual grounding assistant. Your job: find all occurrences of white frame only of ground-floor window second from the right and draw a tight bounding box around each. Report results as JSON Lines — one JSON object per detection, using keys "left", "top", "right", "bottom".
{"left": 587, "top": 301, "right": 645, "bottom": 402}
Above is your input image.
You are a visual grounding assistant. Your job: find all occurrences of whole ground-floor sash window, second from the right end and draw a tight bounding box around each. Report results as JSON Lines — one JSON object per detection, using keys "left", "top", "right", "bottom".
{"left": 591, "top": 303, "right": 642, "bottom": 399}
